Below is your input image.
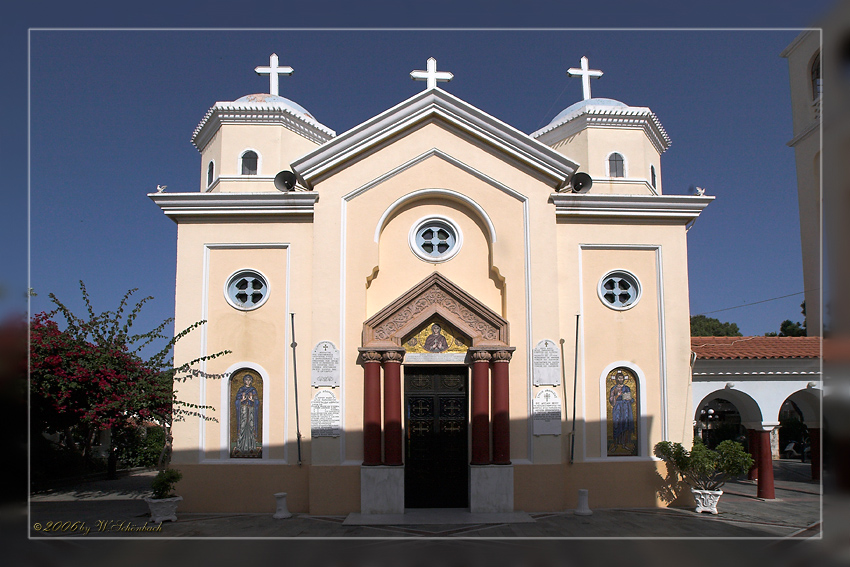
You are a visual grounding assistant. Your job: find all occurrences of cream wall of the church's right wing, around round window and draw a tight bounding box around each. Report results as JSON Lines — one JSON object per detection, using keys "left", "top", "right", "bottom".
{"left": 558, "top": 221, "right": 692, "bottom": 461}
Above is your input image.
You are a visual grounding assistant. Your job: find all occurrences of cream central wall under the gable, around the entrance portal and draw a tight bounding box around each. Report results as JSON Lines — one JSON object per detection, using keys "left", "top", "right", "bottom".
{"left": 304, "top": 120, "right": 557, "bottom": 463}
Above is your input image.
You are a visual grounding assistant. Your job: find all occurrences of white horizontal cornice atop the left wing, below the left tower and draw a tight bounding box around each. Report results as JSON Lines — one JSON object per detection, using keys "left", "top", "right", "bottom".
{"left": 148, "top": 191, "right": 319, "bottom": 222}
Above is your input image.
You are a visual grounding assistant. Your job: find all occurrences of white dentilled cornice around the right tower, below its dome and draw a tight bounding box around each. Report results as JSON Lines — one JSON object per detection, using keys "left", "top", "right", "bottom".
{"left": 529, "top": 105, "right": 672, "bottom": 154}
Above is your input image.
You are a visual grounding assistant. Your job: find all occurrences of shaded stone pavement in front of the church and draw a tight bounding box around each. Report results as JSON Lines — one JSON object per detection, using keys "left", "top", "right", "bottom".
{"left": 28, "top": 460, "right": 822, "bottom": 540}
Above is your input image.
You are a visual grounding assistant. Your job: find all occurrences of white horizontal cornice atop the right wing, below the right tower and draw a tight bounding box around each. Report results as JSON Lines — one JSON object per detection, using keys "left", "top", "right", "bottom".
{"left": 550, "top": 193, "right": 714, "bottom": 222}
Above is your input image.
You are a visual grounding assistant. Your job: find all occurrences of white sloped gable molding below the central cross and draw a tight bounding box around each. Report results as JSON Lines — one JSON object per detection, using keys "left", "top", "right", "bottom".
{"left": 292, "top": 88, "right": 578, "bottom": 190}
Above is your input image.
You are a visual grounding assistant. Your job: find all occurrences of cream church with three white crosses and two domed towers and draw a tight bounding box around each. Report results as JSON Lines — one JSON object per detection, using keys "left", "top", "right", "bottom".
{"left": 151, "top": 55, "right": 712, "bottom": 514}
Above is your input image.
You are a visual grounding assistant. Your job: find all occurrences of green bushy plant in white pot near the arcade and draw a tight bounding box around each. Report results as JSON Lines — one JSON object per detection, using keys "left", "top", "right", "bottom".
{"left": 655, "top": 439, "right": 753, "bottom": 514}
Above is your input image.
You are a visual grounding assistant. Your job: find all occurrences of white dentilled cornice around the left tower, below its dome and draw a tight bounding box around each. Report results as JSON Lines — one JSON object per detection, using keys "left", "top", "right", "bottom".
{"left": 192, "top": 102, "right": 336, "bottom": 151}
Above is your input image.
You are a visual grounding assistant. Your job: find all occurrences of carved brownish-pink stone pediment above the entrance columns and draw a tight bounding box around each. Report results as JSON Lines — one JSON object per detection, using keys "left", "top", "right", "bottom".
{"left": 362, "top": 272, "right": 510, "bottom": 349}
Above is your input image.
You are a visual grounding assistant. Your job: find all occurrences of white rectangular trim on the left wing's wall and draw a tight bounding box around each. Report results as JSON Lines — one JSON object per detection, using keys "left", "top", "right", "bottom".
{"left": 198, "top": 242, "right": 292, "bottom": 464}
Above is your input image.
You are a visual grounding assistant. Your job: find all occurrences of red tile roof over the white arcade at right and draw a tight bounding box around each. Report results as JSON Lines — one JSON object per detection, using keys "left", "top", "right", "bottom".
{"left": 691, "top": 337, "right": 821, "bottom": 359}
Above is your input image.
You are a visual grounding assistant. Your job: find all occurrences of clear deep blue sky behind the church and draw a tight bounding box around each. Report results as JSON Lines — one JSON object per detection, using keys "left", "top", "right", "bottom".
{"left": 0, "top": 3, "right": 828, "bottom": 344}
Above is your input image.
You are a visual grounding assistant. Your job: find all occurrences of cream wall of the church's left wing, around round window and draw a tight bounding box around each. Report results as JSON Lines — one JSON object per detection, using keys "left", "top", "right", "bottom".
{"left": 167, "top": 222, "right": 312, "bottom": 463}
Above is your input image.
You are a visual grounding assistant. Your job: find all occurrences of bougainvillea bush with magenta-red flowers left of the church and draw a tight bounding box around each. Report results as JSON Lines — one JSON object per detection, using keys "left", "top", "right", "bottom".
{"left": 30, "top": 282, "right": 228, "bottom": 478}
